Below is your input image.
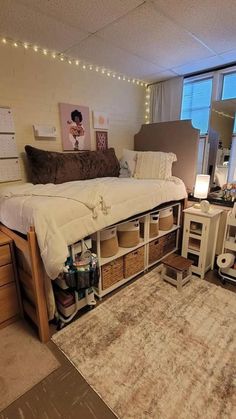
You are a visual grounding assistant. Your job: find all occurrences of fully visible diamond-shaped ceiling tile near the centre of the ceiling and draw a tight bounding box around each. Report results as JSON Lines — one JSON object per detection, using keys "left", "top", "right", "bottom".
{"left": 99, "top": 3, "right": 212, "bottom": 68}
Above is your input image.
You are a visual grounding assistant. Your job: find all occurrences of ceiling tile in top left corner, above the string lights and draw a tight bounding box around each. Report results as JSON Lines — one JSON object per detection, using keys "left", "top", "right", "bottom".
{"left": 0, "top": 0, "right": 88, "bottom": 51}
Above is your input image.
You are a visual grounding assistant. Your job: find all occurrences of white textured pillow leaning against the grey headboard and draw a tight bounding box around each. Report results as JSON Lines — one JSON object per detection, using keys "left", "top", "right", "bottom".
{"left": 134, "top": 151, "right": 177, "bottom": 180}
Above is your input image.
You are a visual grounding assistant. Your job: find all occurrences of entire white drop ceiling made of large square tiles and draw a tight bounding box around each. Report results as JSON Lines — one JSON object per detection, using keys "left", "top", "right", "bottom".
{"left": 0, "top": 0, "right": 236, "bottom": 82}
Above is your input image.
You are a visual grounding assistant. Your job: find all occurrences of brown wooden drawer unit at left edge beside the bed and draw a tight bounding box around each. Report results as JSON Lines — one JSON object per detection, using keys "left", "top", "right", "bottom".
{"left": 0, "top": 232, "right": 21, "bottom": 328}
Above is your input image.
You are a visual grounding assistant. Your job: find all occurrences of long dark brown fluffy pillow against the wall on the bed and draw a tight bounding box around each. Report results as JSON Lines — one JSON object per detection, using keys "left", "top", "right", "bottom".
{"left": 25, "top": 145, "right": 119, "bottom": 184}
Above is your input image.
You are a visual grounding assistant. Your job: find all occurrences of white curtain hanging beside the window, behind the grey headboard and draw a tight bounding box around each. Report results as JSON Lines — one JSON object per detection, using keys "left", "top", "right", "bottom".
{"left": 150, "top": 77, "right": 183, "bottom": 122}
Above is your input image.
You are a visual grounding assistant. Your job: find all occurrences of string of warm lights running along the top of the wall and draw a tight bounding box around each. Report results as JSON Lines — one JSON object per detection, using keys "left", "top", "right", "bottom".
{"left": 1, "top": 38, "right": 147, "bottom": 88}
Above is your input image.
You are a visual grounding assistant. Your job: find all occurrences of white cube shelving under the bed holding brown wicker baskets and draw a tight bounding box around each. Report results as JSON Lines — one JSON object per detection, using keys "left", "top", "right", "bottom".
{"left": 93, "top": 202, "right": 181, "bottom": 298}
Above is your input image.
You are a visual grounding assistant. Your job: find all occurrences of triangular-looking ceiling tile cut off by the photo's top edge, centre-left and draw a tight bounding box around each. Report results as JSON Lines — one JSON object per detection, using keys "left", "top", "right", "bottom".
{"left": 18, "top": 0, "right": 143, "bottom": 33}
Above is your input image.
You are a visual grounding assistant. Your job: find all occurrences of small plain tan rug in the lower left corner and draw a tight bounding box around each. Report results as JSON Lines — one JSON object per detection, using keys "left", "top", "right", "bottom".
{"left": 0, "top": 321, "right": 60, "bottom": 411}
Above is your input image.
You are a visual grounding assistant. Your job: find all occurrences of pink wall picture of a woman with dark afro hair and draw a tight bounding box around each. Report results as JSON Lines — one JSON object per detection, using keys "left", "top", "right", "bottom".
{"left": 59, "top": 103, "right": 91, "bottom": 151}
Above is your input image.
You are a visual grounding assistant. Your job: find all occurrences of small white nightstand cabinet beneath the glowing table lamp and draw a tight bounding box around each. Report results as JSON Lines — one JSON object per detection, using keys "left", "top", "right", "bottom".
{"left": 182, "top": 207, "right": 222, "bottom": 279}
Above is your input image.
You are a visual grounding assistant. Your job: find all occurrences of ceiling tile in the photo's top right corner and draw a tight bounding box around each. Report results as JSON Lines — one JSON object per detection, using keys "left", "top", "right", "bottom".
{"left": 153, "top": 0, "right": 236, "bottom": 53}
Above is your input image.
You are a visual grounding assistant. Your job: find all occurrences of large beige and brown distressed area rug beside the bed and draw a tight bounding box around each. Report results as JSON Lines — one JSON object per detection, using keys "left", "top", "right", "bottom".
{"left": 53, "top": 270, "right": 236, "bottom": 419}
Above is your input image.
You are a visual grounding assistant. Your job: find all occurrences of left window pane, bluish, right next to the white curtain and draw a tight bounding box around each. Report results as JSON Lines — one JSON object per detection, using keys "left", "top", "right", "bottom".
{"left": 181, "top": 77, "right": 212, "bottom": 134}
